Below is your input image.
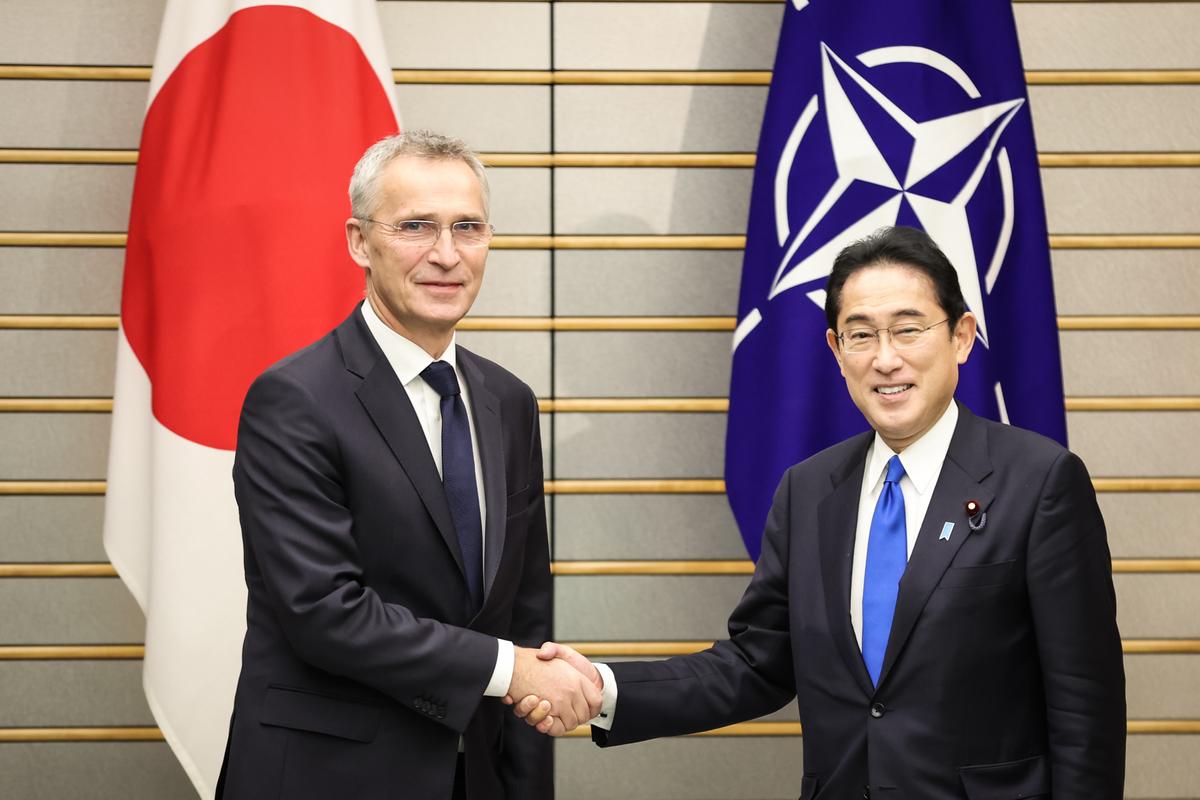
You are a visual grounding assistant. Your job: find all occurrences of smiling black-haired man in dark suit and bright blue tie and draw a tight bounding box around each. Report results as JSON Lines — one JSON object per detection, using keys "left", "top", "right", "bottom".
{"left": 516, "top": 228, "right": 1126, "bottom": 800}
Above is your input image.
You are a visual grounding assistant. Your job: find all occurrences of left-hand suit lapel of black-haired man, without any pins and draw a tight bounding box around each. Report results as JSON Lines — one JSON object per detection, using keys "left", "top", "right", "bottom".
{"left": 817, "top": 432, "right": 875, "bottom": 694}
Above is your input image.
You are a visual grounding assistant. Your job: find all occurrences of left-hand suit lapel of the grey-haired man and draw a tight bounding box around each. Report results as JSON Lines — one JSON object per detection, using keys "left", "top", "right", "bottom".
{"left": 337, "top": 308, "right": 466, "bottom": 575}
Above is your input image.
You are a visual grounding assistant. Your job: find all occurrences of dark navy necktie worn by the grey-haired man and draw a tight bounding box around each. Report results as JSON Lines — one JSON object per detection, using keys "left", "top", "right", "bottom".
{"left": 421, "top": 361, "right": 484, "bottom": 613}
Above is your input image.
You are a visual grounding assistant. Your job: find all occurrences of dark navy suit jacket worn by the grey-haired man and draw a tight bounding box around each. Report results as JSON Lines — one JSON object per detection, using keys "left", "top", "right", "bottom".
{"left": 217, "top": 308, "right": 553, "bottom": 800}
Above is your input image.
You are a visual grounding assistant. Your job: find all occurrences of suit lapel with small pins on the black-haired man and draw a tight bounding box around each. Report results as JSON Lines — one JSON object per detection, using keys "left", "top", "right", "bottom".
{"left": 880, "top": 404, "right": 994, "bottom": 685}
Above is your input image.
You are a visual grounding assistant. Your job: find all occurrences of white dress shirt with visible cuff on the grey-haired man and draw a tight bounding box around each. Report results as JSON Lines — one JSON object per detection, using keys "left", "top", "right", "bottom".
{"left": 362, "top": 300, "right": 515, "bottom": 697}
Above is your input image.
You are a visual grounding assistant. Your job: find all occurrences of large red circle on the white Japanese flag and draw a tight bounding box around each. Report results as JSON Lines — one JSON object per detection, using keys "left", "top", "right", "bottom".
{"left": 121, "top": 6, "right": 396, "bottom": 450}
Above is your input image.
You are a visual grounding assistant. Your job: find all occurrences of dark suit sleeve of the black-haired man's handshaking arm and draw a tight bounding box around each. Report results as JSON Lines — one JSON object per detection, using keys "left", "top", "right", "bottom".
{"left": 592, "top": 473, "right": 796, "bottom": 747}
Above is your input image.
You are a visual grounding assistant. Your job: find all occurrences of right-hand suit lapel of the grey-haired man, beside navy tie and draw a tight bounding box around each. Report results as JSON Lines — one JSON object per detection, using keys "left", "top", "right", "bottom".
{"left": 458, "top": 347, "right": 508, "bottom": 597}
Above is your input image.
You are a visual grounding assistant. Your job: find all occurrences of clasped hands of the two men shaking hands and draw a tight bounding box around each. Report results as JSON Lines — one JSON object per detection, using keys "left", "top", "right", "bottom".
{"left": 503, "top": 642, "right": 604, "bottom": 736}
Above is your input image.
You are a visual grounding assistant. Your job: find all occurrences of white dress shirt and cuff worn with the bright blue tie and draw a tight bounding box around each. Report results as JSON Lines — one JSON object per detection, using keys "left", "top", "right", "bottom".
{"left": 592, "top": 401, "right": 959, "bottom": 730}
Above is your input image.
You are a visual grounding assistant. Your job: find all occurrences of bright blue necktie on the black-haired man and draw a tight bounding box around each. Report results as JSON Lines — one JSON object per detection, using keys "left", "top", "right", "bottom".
{"left": 863, "top": 456, "right": 908, "bottom": 685}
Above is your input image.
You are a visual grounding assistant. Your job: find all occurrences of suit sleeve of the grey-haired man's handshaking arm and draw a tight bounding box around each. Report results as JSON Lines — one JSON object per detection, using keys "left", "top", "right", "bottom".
{"left": 234, "top": 369, "right": 498, "bottom": 733}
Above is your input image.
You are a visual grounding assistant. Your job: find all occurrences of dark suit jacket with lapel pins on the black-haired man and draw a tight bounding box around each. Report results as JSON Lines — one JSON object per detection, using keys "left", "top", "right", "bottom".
{"left": 593, "top": 408, "right": 1126, "bottom": 800}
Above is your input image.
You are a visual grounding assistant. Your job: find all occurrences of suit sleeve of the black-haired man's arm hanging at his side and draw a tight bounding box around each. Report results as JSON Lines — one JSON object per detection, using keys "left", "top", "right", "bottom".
{"left": 1027, "top": 452, "right": 1126, "bottom": 800}
